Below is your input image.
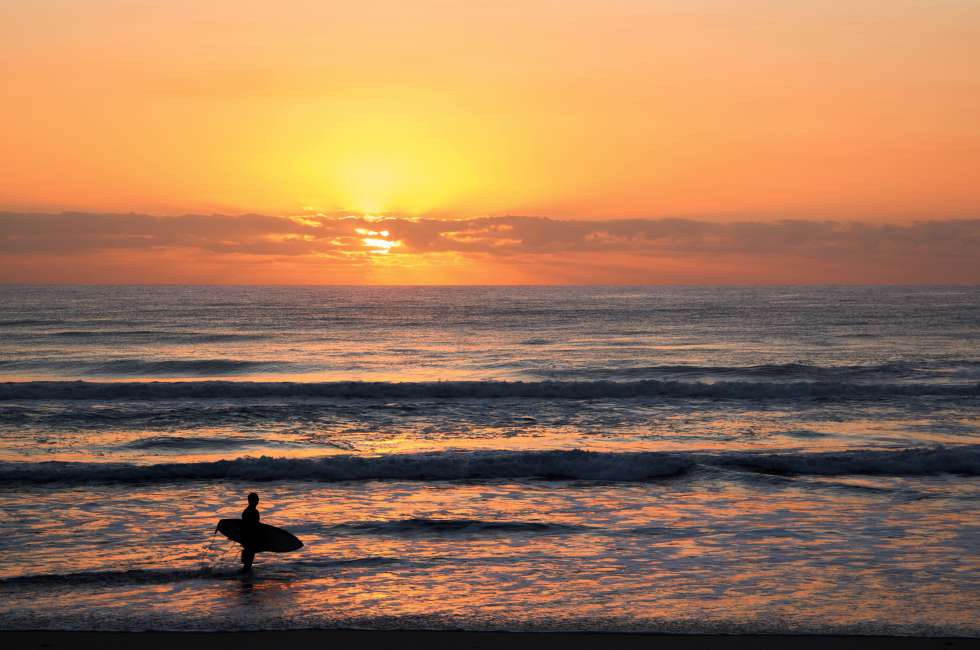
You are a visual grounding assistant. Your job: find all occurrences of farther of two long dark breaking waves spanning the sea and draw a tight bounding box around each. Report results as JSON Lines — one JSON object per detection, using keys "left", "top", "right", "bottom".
{"left": 0, "top": 379, "right": 980, "bottom": 400}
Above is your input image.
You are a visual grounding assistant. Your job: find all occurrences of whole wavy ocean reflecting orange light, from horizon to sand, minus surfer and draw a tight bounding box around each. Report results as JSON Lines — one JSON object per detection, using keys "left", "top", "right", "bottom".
{"left": 0, "top": 286, "right": 980, "bottom": 636}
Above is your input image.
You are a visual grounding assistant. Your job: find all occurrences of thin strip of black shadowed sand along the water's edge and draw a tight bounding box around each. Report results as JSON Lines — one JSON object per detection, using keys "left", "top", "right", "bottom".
{"left": 0, "top": 630, "right": 980, "bottom": 650}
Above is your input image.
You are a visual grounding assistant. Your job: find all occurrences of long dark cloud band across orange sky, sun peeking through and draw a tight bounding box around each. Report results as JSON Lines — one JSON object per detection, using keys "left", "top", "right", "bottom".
{"left": 0, "top": 212, "right": 980, "bottom": 263}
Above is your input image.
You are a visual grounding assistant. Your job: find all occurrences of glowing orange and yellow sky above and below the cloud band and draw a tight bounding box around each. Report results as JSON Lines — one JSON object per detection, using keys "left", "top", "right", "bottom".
{"left": 0, "top": 0, "right": 980, "bottom": 281}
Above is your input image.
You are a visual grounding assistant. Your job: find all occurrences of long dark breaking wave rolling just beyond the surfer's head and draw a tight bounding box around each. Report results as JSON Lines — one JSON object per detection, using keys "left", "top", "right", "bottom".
{"left": 0, "top": 445, "right": 980, "bottom": 484}
